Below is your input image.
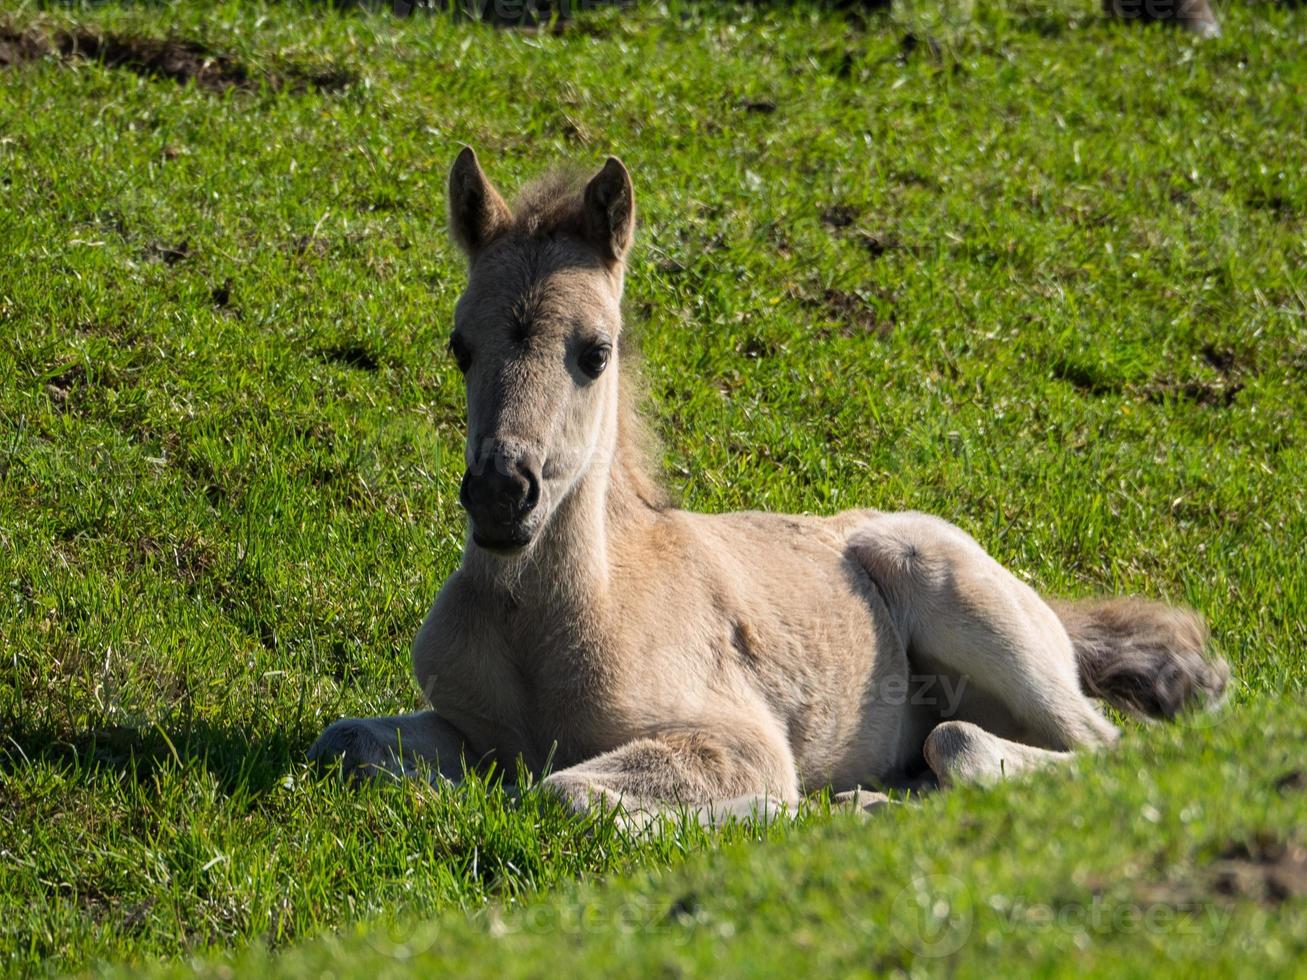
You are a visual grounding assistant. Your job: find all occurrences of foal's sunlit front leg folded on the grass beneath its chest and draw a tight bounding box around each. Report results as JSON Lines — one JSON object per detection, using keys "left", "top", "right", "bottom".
{"left": 542, "top": 719, "right": 799, "bottom": 828}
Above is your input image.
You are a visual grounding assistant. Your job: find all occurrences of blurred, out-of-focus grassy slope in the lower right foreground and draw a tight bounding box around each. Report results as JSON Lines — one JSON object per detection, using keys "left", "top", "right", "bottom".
{"left": 148, "top": 704, "right": 1307, "bottom": 979}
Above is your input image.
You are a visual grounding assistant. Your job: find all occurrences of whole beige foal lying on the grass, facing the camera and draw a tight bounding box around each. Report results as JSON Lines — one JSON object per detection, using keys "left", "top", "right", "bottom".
{"left": 310, "top": 149, "right": 1229, "bottom": 819}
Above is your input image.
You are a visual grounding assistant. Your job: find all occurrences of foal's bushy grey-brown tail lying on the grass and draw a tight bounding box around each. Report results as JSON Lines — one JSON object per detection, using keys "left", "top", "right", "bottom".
{"left": 1050, "top": 598, "right": 1230, "bottom": 719}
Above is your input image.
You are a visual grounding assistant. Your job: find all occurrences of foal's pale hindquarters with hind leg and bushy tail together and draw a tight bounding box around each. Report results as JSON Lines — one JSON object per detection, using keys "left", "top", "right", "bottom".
{"left": 848, "top": 511, "right": 1229, "bottom": 751}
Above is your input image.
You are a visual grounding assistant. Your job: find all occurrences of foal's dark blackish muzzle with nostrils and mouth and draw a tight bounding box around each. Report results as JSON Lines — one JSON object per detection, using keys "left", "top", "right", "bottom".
{"left": 459, "top": 443, "right": 540, "bottom": 551}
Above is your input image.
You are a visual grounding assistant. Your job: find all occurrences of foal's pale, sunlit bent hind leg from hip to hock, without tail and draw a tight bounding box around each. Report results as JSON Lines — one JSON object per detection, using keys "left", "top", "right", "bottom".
{"left": 850, "top": 512, "right": 1119, "bottom": 750}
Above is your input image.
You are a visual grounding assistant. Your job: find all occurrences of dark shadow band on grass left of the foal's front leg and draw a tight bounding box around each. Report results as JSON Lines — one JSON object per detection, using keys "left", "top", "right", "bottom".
{"left": 0, "top": 721, "right": 306, "bottom": 794}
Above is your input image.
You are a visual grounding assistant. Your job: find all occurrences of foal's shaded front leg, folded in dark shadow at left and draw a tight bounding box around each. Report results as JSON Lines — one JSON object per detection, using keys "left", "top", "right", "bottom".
{"left": 308, "top": 711, "right": 471, "bottom": 783}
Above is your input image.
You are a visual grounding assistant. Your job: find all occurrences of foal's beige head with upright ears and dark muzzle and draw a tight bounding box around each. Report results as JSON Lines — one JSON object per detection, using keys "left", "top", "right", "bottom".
{"left": 450, "top": 148, "right": 635, "bottom": 554}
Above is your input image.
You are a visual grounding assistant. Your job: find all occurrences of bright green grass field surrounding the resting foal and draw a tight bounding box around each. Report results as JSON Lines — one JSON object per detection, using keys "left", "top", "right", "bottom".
{"left": 0, "top": 0, "right": 1307, "bottom": 977}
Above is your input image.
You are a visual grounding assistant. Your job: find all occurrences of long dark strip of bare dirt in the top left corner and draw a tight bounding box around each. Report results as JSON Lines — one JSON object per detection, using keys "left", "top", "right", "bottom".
{"left": 0, "top": 25, "right": 357, "bottom": 91}
